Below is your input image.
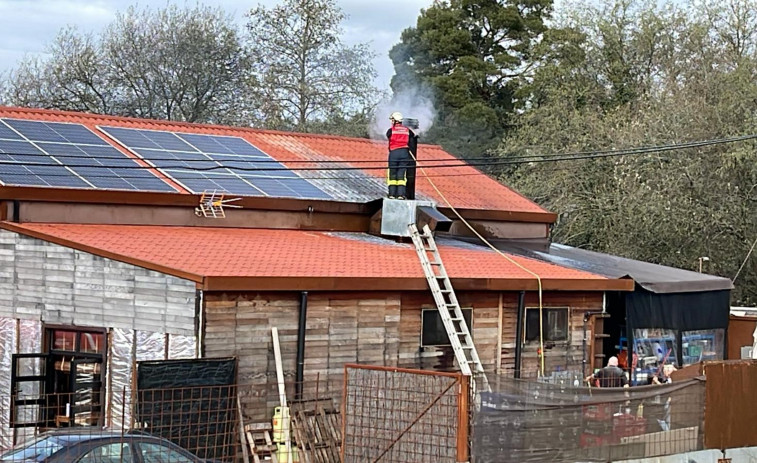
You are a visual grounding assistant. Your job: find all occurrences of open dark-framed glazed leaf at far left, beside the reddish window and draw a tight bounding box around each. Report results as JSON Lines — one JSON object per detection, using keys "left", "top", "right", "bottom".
{"left": 10, "top": 354, "right": 49, "bottom": 428}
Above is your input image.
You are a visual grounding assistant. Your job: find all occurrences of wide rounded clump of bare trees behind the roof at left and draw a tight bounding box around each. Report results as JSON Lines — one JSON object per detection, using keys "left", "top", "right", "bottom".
{"left": 4, "top": 6, "right": 254, "bottom": 123}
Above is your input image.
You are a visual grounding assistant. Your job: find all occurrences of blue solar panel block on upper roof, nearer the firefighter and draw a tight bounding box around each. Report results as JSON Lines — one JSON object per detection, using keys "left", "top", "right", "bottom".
{"left": 100, "top": 127, "right": 331, "bottom": 199}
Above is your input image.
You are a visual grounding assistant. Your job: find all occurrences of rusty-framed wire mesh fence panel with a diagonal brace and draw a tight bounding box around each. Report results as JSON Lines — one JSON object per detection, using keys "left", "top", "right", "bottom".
{"left": 343, "top": 365, "right": 468, "bottom": 463}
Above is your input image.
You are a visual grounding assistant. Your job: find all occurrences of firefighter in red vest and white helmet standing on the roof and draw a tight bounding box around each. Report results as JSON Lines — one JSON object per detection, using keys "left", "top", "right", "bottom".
{"left": 386, "top": 111, "right": 418, "bottom": 199}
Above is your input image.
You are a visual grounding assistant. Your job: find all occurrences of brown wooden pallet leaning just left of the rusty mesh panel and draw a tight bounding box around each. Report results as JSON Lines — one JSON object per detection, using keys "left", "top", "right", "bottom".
{"left": 289, "top": 398, "right": 342, "bottom": 463}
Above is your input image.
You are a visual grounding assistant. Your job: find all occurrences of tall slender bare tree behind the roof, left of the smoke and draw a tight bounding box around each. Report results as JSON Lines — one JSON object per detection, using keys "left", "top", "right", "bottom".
{"left": 247, "top": 0, "right": 377, "bottom": 131}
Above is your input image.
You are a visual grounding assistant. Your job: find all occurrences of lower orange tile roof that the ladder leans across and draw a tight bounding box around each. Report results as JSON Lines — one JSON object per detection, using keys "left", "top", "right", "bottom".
{"left": 2, "top": 222, "right": 626, "bottom": 290}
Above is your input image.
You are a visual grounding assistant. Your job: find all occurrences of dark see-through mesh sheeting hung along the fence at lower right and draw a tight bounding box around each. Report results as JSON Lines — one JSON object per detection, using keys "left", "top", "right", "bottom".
{"left": 471, "top": 377, "right": 705, "bottom": 463}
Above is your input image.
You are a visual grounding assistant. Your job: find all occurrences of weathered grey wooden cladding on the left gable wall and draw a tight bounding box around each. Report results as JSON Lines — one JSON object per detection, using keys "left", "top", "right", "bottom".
{"left": 0, "top": 230, "right": 196, "bottom": 336}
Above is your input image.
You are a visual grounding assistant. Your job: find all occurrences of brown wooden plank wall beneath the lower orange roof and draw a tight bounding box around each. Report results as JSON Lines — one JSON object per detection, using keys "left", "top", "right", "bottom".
{"left": 203, "top": 292, "right": 602, "bottom": 420}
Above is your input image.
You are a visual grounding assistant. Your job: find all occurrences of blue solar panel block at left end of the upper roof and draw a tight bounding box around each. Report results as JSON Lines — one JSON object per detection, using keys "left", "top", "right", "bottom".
{"left": 0, "top": 119, "right": 176, "bottom": 192}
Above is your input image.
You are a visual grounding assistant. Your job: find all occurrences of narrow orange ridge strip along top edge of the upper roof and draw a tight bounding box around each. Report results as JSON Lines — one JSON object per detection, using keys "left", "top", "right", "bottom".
{"left": 0, "top": 105, "right": 442, "bottom": 149}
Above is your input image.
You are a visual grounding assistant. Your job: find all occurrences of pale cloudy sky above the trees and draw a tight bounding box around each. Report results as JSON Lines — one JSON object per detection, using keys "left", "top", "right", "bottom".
{"left": 0, "top": 0, "right": 432, "bottom": 89}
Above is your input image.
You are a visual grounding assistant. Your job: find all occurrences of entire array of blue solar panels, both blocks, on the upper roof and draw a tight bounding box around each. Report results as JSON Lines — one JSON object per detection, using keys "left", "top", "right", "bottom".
{"left": 0, "top": 118, "right": 333, "bottom": 199}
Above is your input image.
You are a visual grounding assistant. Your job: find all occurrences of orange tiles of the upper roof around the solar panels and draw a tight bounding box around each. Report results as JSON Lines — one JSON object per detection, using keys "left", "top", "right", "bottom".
{"left": 0, "top": 107, "right": 554, "bottom": 217}
